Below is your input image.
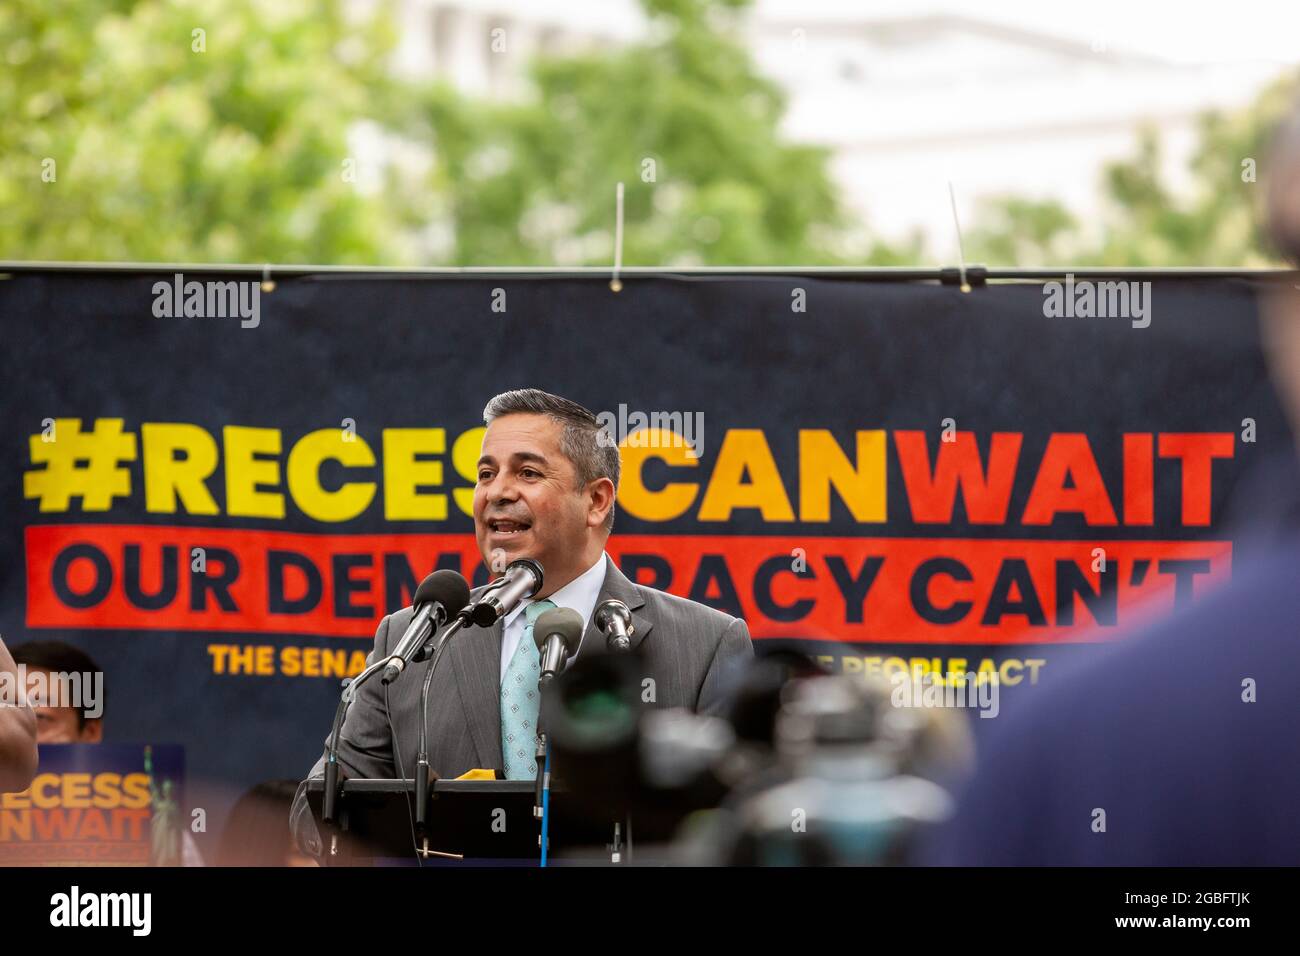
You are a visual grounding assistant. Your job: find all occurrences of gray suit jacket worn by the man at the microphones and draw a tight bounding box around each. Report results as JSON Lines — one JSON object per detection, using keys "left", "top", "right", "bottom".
{"left": 290, "top": 558, "right": 754, "bottom": 856}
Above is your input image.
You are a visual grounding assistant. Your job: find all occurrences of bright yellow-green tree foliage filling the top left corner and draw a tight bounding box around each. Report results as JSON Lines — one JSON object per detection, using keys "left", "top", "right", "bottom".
{"left": 0, "top": 0, "right": 402, "bottom": 263}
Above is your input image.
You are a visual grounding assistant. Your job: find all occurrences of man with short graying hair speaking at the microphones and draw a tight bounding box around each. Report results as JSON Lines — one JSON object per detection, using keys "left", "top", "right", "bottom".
{"left": 291, "top": 389, "right": 754, "bottom": 856}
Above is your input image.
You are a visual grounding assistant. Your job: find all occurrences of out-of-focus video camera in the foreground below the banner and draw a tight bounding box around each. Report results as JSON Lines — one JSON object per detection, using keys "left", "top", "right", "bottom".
{"left": 543, "top": 652, "right": 971, "bottom": 866}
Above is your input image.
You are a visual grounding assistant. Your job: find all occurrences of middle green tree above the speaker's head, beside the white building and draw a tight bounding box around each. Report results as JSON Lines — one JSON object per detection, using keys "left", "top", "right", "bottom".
{"left": 408, "top": 0, "right": 850, "bottom": 265}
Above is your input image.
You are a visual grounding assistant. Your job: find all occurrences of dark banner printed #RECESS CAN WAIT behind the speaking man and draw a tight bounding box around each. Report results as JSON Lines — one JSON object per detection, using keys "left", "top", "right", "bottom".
{"left": 0, "top": 273, "right": 1294, "bottom": 849}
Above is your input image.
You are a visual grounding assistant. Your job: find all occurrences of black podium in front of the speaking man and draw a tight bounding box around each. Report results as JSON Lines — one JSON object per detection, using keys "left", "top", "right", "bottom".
{"left": 307, "top": 778, "right": 626, "bottom": 866}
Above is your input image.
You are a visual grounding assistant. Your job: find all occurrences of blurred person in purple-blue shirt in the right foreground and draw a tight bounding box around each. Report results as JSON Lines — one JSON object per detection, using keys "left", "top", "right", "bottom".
{"left": 919, "top": 102, "right": 1300, "bottom": 866}
